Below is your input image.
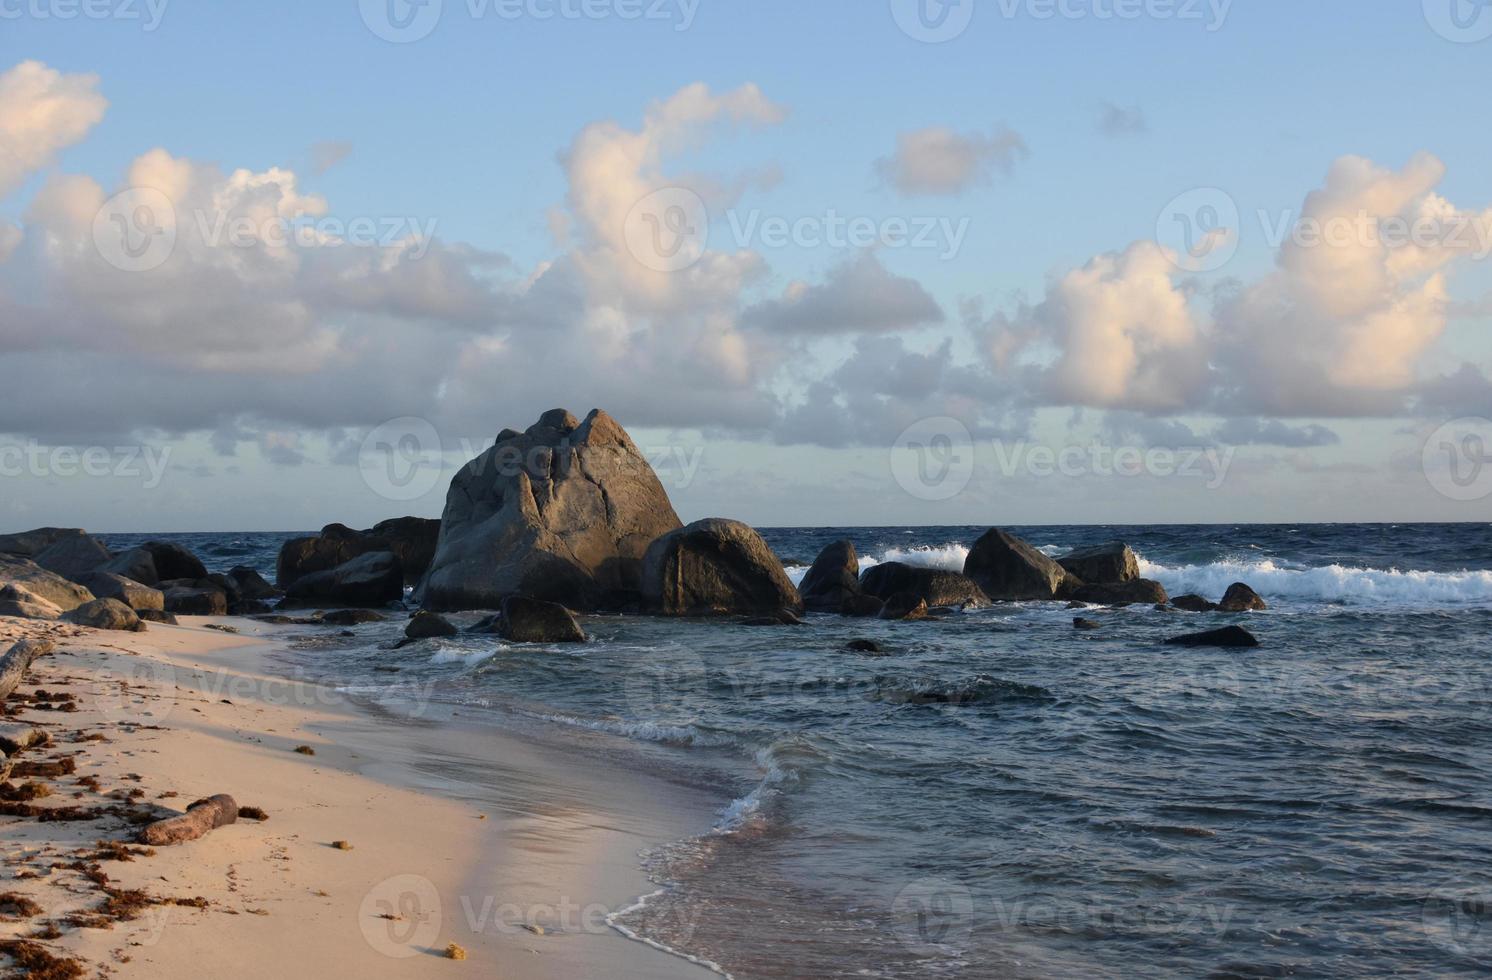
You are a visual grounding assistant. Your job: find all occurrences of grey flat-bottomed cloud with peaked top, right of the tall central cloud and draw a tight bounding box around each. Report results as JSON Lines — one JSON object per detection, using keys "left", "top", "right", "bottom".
{"left": 743, "top": 252, "right": 944, "bottom": 337}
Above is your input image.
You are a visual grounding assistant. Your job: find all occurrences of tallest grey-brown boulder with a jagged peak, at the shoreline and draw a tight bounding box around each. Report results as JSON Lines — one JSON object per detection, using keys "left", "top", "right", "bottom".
{"left": 421, "top": 409, "right": 683, "bottom": 612}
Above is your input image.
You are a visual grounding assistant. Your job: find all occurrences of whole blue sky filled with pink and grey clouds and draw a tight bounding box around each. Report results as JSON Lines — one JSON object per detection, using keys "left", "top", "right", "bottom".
{"left": 0, "top": 0, "right": 1492, "bottom": 531}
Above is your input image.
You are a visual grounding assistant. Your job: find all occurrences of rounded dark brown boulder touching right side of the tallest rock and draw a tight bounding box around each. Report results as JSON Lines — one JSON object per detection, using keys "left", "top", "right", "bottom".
{"left": 642, "top": 518, "right": 803, "bottom": 616}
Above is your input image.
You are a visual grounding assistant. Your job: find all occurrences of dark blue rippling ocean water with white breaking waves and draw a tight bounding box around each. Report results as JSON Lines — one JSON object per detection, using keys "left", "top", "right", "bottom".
{"left": 104, "top": 524, "right": 1492, "bottom": 980}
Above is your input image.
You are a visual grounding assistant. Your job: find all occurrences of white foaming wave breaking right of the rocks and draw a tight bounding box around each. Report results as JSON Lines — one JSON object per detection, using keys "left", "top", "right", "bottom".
{"left": 1140, "top": 558, "right": 1492, "bottom": 606}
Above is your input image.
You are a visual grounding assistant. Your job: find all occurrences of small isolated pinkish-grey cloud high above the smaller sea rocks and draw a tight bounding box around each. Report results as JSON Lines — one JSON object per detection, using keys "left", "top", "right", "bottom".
{"left": 876, "top": 127, "right": 1029, "bottom": 197}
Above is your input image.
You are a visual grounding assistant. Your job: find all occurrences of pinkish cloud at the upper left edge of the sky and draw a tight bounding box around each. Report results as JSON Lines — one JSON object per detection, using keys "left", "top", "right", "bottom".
{"left": 0, "top": 61, "right": 109, "bottom": 197}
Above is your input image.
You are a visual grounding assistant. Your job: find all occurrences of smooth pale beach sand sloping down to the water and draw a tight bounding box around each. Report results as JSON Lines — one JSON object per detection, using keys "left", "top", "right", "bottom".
{"left": 0, "top": 618, "right": 719, "bottom": 980}
